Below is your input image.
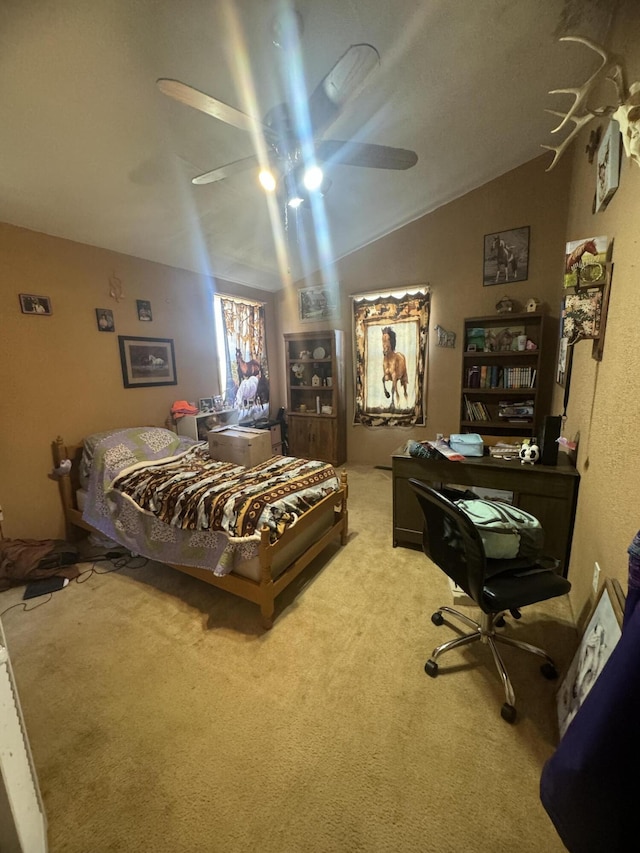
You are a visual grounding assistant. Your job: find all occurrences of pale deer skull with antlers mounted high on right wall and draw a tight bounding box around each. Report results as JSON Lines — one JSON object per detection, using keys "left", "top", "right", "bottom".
{"left": 542, "top": 36, "right": 640, "bottom": 172}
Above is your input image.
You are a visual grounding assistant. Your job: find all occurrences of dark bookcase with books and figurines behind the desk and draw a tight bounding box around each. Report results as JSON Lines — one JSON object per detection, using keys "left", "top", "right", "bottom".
{"left": 460, "top": 312, "right": 555, "bottom": 438}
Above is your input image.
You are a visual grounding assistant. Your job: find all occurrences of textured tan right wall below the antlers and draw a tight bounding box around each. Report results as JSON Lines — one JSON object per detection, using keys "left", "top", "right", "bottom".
{"left": 556, "top": 3, "right": 640, "bottom": 620}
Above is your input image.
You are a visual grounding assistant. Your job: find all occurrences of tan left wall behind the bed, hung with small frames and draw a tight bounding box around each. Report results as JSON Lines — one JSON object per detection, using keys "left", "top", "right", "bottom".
{"left": 0, "top": 224, "right": 278, "bottom": 538}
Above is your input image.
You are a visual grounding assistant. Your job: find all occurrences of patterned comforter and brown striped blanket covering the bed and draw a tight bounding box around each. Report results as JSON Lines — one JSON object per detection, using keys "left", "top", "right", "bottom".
{"left": 83, "top": 427, "right": 339, "bottom": 575}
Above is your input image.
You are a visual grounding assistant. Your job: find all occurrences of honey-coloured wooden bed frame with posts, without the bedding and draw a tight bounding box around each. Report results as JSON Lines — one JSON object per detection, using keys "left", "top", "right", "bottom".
{"left": 53, "top": 436, "right": 349, "bottom": 629}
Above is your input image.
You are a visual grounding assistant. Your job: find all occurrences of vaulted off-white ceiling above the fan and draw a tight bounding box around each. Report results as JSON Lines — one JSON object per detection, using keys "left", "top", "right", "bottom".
{"left": 0, "top": 0, "right": 615, "bottom": 290}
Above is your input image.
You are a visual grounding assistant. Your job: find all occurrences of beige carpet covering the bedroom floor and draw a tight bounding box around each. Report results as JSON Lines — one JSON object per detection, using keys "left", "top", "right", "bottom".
{"left": 0, "top": 466, "right": 576, "bottom": 853}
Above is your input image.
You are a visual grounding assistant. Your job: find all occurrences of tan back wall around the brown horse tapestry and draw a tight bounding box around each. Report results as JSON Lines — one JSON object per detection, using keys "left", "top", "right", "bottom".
{"left": 278, "top": 155, "right": 571, "bottom": 465}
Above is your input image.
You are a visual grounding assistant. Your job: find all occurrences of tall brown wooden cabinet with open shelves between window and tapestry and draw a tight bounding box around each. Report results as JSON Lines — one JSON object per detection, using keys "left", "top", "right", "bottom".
{"left": 284, "top": 329, "right": 346, "bottom": 465}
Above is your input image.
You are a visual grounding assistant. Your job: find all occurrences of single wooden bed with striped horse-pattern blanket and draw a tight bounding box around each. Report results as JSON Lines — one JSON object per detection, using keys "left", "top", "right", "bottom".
{"left": 53, "top": 427, "right": 348, "bottom": 629}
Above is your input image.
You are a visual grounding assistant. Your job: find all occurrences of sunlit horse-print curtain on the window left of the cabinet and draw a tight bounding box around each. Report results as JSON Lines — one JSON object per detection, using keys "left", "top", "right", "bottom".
{"left": 220, "top": 296, "right": 269, "bottom": 422}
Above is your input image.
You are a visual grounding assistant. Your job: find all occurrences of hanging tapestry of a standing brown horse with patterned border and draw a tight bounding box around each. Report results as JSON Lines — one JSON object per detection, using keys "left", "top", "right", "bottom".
{"left": 353, "top": 288, "right": 429, "bottom": 426}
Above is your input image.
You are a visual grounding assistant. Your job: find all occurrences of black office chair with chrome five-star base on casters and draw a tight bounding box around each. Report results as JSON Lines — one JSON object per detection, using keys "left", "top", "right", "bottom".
{"left": 409, "top": 479, "right": 571, "bottom": 723}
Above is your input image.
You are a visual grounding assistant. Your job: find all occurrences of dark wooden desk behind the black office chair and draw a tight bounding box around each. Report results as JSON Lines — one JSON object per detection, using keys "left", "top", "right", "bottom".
{"left": 391, "top": 447, "right": 580, "bottom": 576}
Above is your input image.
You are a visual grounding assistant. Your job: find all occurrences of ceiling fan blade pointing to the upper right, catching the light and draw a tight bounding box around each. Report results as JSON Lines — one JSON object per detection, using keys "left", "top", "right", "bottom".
{"left": 308, "top": 44, "right": 380, "bottom": 136}
